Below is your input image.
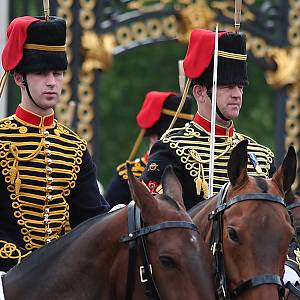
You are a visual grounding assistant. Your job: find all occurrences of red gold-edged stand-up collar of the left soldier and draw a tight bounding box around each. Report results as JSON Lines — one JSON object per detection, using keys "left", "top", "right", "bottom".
{"left": 16, "top": 105, "right": 54, "bottom": 127}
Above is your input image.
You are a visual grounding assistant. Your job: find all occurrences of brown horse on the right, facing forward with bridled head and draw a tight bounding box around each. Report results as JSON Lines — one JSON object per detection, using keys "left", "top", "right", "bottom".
{"left": 190, "top": 141, "right": 296, "bottom": 300}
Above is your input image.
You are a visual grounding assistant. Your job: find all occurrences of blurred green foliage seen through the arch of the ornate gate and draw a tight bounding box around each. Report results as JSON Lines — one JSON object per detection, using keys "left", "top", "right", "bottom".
{"left": 98, "top": 42, "right": 275, "bottom": 187}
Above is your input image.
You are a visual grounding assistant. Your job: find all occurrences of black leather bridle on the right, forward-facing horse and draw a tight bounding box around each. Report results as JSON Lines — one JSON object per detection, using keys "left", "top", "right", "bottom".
{"left": 209, "top": 184, "right": 286, "bottom": 300}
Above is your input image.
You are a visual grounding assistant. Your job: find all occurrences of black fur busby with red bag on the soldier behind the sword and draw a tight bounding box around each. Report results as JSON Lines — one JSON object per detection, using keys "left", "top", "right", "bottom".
{"left": 184, "top": 29, "right": 248, "bottom": 88}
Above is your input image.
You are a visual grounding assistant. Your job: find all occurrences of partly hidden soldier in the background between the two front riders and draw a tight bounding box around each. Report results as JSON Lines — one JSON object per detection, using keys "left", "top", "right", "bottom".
{"left": 105, "top": 91, "right": 193, "bottom": 206}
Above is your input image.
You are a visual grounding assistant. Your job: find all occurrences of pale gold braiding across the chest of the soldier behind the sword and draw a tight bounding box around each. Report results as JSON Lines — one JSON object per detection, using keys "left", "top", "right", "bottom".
{"left": 162, "top": 122, "right": 274, "bottom": 197}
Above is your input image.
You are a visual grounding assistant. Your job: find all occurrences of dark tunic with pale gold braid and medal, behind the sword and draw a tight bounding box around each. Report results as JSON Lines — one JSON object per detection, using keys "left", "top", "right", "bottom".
{"left": 142, "top": 114, "right": 274, "bottom": 209}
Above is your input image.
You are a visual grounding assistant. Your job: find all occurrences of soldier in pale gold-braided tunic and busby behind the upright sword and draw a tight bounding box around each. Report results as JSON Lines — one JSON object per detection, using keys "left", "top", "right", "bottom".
{"left": 142, "top": 29, "right": 275, "bottom": 209}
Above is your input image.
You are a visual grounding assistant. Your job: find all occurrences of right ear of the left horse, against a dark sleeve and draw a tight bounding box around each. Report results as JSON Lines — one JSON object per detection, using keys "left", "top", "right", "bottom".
{"left": 162, "top": 165, "right": 185, "bottom": 207}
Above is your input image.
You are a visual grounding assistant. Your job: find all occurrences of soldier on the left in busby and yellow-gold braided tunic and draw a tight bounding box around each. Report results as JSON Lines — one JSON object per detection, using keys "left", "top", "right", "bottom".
{"left": 0, "top": 17, "right": 109, "bottom": 271}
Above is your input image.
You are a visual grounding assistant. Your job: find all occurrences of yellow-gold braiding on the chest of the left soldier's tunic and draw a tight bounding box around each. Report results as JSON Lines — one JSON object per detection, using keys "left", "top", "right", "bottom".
{"left": 0, "top": 116, "right": 87, "bottom": 251}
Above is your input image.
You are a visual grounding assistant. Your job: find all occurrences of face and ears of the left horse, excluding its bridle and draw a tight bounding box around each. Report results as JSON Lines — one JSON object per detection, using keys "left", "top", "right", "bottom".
{"left": 128, "top": 167, "right": 216, "bottom": 300}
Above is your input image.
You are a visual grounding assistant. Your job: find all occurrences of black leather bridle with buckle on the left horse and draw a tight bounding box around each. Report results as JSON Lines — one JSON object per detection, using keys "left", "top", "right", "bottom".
{"left": 120, "top": 201, "right": 199, "bottom": 300}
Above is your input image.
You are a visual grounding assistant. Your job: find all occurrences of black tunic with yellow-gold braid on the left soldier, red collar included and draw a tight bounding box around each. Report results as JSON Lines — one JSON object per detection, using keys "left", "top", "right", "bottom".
{"left": 0, "top": 106, "right": 109, "bottom": 271}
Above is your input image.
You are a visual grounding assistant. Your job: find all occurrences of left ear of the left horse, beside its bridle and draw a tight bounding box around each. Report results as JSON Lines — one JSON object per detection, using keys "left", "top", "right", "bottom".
{"left": 126, "top": 162, "right": 156, "bottom": 210}
